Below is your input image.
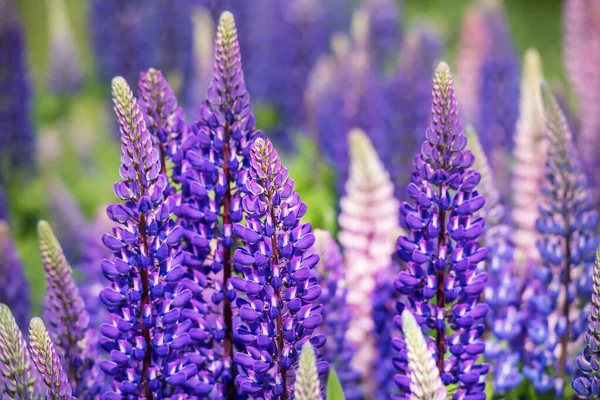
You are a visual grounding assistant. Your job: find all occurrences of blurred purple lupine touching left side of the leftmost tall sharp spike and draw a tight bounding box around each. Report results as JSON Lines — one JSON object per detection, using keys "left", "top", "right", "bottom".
{"left": 77, "top": 207, "right": 112, "bottom": 330}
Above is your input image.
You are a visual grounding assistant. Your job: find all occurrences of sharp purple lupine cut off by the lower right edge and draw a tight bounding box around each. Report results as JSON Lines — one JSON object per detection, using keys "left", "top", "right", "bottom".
{"left": 572, "top": 248, "right": 600, "bottom": 399}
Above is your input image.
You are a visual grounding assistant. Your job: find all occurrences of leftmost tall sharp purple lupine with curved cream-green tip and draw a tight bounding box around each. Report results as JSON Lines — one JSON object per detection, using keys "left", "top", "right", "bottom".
{"left": 100, "top": 77, "right": 202, "bottom": 399}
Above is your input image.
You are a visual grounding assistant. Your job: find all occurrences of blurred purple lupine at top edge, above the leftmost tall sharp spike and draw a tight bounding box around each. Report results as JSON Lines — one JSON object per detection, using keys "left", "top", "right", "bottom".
{"left": 88, "top": 0, "right": 161, "bottom": 91}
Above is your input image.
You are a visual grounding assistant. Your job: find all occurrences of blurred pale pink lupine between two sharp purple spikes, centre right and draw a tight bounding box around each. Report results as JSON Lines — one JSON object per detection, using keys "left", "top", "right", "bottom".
{"left": 338, "top": 129, "right": 399, "bottom": 390}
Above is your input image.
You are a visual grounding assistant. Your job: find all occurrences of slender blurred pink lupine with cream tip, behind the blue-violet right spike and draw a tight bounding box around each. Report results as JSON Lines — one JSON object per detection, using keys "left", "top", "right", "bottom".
{"left": 511, "top": 49, "right": 547, "bottom": 274}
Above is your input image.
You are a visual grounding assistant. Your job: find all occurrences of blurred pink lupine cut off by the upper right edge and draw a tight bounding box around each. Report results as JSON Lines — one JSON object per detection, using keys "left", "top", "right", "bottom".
{"left": 563, "top": 0, "right": 600, "bottom": 204}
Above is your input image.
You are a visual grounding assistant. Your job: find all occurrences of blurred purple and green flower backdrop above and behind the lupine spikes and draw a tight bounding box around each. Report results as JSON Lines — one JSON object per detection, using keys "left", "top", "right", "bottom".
{"left": 0, "top": 0, "right": 576, "bottom": 307}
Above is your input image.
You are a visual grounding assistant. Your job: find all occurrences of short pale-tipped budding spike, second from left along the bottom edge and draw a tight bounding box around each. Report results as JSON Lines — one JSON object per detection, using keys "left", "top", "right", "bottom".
{"left": 29, "top": 317, "right": 75, "bottom": 400}
